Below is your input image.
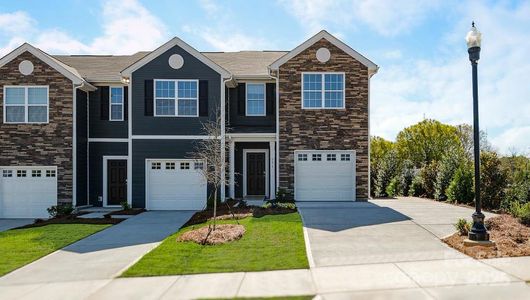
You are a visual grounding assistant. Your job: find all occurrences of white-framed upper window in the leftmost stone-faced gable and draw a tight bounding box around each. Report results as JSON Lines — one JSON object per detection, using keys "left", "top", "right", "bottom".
{"left": 4, "top": 86, "right": 49, "bottom": 123}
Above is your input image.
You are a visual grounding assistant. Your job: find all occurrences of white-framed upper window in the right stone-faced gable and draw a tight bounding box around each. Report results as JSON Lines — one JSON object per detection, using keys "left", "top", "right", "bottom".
{"left": 302, "top": 73, "right": 344, "bottom": 109}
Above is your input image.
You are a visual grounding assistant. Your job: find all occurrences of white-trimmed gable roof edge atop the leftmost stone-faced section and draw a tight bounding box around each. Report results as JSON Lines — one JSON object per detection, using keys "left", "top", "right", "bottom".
{"left": 0, "top": 43, "right": 95, "bottom": 90}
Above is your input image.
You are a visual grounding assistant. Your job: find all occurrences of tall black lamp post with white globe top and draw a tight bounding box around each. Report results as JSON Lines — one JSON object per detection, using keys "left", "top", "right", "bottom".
{"left": 466, "top": 22, "right": 490, "bottom": 241}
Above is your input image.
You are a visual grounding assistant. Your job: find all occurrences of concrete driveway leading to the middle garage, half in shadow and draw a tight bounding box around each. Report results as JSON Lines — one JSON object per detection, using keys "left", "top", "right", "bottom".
{"left": 0, "top": 211, "right": 194, "bottom": 286}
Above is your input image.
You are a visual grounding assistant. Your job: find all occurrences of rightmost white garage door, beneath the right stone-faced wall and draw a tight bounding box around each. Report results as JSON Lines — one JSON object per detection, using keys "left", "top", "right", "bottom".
{"left": 294, "top": 150, "right": 355, "bottom": 201}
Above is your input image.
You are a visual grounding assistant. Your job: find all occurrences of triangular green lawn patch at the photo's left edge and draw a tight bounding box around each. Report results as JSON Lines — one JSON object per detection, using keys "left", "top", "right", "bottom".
{"left": 0, "top": 224, "right": 110, "bottom": 276}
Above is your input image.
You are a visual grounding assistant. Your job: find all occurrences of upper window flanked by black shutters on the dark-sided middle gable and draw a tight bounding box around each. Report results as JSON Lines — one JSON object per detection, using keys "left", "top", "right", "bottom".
{"left": 154, "top": 79, "right": 199, "bottom": 117}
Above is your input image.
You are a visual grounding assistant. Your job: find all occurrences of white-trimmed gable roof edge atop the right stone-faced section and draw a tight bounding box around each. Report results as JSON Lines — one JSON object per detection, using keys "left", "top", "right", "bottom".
{"left": 270, "top": 30, "right": 379, "bottom": 74}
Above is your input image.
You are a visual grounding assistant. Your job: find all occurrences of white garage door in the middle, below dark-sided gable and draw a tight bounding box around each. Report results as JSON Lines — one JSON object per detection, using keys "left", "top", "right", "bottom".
{"left": 146, "top": 159, "right": 207, "bottom": 210}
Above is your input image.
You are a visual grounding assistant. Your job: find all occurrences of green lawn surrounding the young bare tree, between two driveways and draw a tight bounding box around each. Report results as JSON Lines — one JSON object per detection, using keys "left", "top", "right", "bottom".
{"left": 122, "top": 213, "right": 309, "bottom": 277}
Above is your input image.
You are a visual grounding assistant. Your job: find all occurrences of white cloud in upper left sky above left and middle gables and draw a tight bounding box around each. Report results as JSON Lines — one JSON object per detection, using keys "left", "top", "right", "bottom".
{"left": 0, "top": 0, "right": 169, "bottom": 55}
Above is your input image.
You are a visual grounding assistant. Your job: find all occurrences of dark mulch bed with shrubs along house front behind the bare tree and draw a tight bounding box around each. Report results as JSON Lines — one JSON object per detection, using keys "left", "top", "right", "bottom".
{"left": 183, "top": 200, "right": 296, "bottom": 227}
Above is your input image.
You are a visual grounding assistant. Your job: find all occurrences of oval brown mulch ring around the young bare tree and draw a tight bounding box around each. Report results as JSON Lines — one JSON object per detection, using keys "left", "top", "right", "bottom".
{"left": 177, "top": 224, "right": 245, "bottom": 245}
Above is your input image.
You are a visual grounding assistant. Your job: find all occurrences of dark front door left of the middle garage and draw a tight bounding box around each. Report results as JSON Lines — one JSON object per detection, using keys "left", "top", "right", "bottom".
{"left": 107, "top": 160, "right": 127, "bottom": 205}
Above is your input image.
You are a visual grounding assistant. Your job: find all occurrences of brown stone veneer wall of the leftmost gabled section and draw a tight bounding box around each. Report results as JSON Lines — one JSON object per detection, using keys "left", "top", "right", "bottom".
{"left": 0, "top": 52, "right": 73, "bottom": 203}
